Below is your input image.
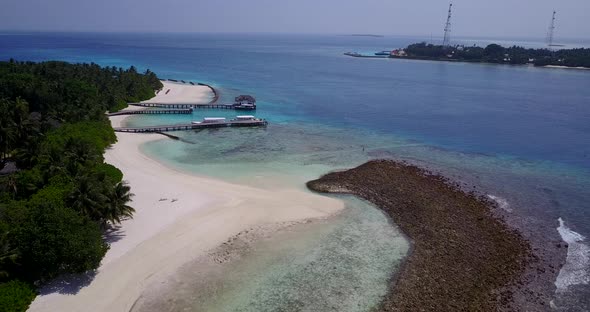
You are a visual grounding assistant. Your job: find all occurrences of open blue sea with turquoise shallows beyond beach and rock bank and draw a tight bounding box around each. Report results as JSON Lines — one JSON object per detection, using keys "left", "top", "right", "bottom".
{"left": 0, "top": 33, "right": 590, "bottom": 310}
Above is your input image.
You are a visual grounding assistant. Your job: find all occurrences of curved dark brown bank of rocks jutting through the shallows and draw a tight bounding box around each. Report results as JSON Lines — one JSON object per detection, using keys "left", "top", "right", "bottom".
{"left": 307, "top": 160, "right": 548, "bottom": 311}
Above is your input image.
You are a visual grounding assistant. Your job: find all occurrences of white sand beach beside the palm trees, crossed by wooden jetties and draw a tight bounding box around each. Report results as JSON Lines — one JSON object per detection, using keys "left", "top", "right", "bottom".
{"left": 29, "top": 82, "right": 344, "bottom": 312}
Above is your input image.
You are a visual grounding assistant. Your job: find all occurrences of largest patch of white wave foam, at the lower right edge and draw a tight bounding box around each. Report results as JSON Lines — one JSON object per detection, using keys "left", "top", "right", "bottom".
{"left": 555, "top": 218, "right": 590, "bottom": 292}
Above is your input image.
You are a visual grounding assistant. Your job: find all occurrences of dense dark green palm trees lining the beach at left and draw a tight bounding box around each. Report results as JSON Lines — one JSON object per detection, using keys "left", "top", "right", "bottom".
{"left": 0, "top": 60, "right": 162, "bottom": 311}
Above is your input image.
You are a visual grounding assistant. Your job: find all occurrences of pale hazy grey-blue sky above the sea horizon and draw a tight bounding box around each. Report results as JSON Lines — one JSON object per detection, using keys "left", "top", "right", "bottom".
{"left": 0, "top": 0, "right": 590, "bottom": 40}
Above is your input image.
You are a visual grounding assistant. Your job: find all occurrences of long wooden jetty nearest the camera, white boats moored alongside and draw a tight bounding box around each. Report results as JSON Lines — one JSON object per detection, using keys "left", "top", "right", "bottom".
{"left": 114, "top": 119, "right": 268, "bottom": 133}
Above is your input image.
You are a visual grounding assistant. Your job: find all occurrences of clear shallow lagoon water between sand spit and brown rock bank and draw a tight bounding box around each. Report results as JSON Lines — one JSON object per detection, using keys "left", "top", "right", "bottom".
{"left": 134, "top": 197, "right": 409, "bottom": 311}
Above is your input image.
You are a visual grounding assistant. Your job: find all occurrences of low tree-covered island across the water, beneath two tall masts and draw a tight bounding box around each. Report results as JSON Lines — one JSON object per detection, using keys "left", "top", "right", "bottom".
{"left": 345, "top": 42, "right": 590, "bottom": 68}
